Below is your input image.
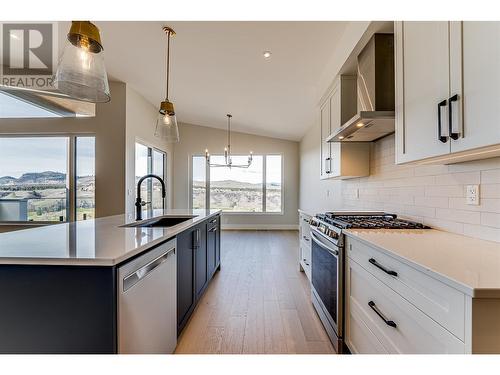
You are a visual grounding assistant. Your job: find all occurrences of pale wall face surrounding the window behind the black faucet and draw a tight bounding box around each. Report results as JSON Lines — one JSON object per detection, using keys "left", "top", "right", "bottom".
{"left": 125, "top": 85, "right": 173, "bottom": 218}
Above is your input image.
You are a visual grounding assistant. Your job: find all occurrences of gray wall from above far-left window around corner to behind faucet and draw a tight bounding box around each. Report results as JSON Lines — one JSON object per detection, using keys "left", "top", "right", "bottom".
{"left": 0, "top": 82, "right": 173, "bottom": 223}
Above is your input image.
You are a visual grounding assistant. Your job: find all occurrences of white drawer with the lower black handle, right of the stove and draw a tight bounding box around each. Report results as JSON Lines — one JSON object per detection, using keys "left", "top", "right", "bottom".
{"left": 347, "top": 259, "right": 465, "bottom": 354}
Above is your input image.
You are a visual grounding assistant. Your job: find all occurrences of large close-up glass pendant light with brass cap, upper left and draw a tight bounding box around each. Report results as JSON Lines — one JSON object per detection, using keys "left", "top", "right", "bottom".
{"left": 54, "top": 21, "right": 111, "bottom": 103}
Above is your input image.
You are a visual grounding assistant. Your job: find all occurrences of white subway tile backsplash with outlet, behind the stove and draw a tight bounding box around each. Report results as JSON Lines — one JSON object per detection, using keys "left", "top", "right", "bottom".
{"left": 340, "top": 136, "right": 500, "bottom": 242}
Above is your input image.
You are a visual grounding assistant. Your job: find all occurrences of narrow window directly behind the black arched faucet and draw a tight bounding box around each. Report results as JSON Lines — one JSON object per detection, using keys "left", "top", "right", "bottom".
{"left": 135, "top": 143, "right": 167, "bottom": 210}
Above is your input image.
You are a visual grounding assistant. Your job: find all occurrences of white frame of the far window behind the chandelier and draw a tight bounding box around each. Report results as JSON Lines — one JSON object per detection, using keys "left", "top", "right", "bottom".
{"left": 188, "top": 152, "right": 285, "bottom": 216}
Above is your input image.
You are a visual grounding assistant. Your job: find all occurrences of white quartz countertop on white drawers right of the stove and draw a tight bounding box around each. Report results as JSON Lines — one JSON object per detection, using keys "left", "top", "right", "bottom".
{"left": 344, "top": 229, "right": 500, "bottom": 298}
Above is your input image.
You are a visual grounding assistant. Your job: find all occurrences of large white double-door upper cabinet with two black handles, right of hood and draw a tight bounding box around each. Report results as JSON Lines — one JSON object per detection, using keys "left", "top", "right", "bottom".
{"left": 394, "top": 22, "right": 500, "bottom": 164}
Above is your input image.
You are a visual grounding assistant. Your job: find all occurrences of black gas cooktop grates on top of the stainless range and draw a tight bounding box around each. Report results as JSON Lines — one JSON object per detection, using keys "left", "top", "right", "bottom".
{"left": 316, "top": 211, "right": 429, "bottom": 229}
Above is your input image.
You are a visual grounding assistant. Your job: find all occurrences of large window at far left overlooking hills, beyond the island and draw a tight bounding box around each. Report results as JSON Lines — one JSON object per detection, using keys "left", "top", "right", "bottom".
{"left": 0, "top": 136, "right": 95, "bottom": 222}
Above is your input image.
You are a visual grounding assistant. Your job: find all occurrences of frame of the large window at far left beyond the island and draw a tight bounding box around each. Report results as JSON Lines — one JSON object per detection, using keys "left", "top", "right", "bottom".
{"left": 0, "top": 132, "right": 96, "bottom": 225}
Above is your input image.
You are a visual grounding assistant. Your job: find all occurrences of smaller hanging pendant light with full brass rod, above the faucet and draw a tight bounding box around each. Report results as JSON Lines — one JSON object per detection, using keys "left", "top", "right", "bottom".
{"left": 155, "top": 26, "right": 179, "bottom": 143}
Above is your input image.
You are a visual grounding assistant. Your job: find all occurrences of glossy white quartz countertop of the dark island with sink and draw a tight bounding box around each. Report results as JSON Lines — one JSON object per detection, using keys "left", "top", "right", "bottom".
{"left": 0, "top": 209, "right": 220, "bottom": 266}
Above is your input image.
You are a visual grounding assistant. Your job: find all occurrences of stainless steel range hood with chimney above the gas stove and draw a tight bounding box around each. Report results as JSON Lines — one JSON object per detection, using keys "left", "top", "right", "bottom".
{"left": 327, "top": 34, "right": 395, "bottom": 142}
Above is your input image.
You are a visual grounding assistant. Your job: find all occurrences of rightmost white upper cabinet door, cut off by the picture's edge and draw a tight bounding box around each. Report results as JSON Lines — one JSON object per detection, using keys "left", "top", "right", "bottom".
{"left": 451, "top": 22, "right": 500, "bottom": 152}
